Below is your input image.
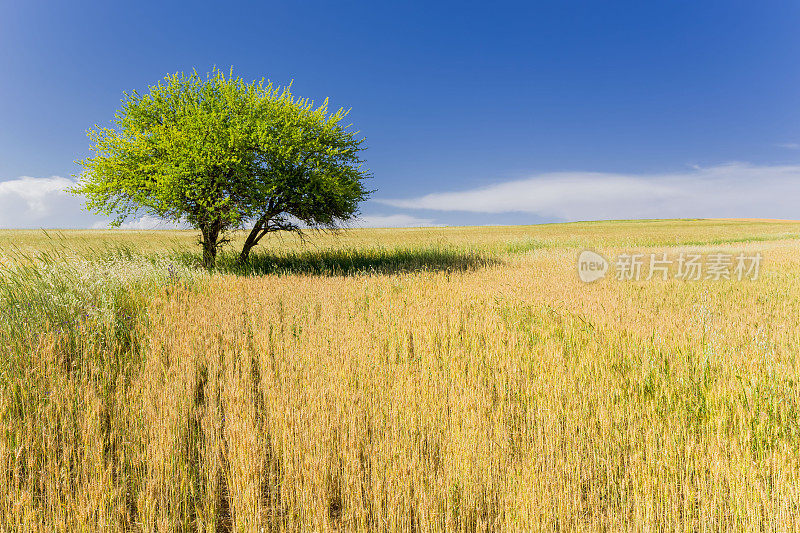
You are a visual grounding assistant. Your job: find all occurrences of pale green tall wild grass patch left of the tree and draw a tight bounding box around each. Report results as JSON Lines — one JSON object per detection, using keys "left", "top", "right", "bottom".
{"left": 0, "top": 247, "right": 198, "bottom": 354}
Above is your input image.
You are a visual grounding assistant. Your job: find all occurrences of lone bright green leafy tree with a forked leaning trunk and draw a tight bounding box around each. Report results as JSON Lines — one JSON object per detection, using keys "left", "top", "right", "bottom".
{"left": 74, "top": 69, "right": 369, "bottom": 268}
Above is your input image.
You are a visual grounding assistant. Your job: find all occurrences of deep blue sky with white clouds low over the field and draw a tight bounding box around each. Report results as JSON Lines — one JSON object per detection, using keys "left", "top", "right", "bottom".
{"left": 0, "top": 0, "right": 800, "bottom": 227}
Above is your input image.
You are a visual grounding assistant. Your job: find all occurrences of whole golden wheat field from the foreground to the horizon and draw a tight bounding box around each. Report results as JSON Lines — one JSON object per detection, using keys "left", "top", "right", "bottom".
{"left": 0, "top": 220, "right": 800, "bottom": 531}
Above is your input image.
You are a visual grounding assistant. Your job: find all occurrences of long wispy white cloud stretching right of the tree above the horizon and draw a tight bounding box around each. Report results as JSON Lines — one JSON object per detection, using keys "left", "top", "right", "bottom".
{"left": 375, "top": 163, "right": 800, "bottom": 220}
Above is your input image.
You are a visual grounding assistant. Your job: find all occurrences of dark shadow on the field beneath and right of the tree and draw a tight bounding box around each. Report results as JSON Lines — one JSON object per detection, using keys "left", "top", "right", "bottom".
{"left": 203, "top": 248, "right": 497, "bottom": 276}
